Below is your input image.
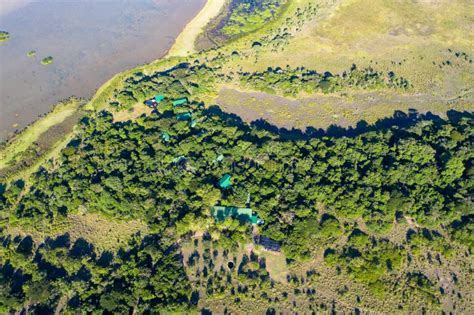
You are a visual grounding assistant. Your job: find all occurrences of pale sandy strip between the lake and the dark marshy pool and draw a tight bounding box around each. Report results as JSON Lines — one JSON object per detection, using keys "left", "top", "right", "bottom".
{"left": 164, "top": 0, "right": 227, "bottom": 58}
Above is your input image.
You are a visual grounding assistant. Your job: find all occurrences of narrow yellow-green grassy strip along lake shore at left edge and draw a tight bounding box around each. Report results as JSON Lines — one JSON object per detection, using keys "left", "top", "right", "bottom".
{"left": 0, "top": 99, "right": 81, "bottom": 170}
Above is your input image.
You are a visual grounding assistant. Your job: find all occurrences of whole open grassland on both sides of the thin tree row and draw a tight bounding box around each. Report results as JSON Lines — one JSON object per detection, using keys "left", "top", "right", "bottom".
{"left": 209, "top": 0, "right": 474, "bottom": 128}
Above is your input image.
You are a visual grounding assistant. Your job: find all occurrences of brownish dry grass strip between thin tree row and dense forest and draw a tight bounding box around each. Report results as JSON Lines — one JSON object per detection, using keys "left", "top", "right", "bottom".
{"left": 216, "top": 89, "right": 473, "bottom": 130}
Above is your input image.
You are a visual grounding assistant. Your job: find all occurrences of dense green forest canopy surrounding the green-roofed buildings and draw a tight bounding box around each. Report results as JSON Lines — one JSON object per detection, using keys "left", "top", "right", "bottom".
{"left": 1, "top": 60, "right": 474, "bottom": 312}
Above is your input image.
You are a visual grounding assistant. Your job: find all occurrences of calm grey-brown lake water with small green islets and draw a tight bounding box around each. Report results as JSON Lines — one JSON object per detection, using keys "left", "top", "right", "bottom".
{"left": 0, "top": 0, "right": 206, "bottom": 140}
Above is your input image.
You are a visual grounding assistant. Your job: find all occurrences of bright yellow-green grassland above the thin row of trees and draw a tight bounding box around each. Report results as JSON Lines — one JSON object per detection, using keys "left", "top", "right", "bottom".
{"left": 223, "top": 0, "right": 474, "bottom": 95}
